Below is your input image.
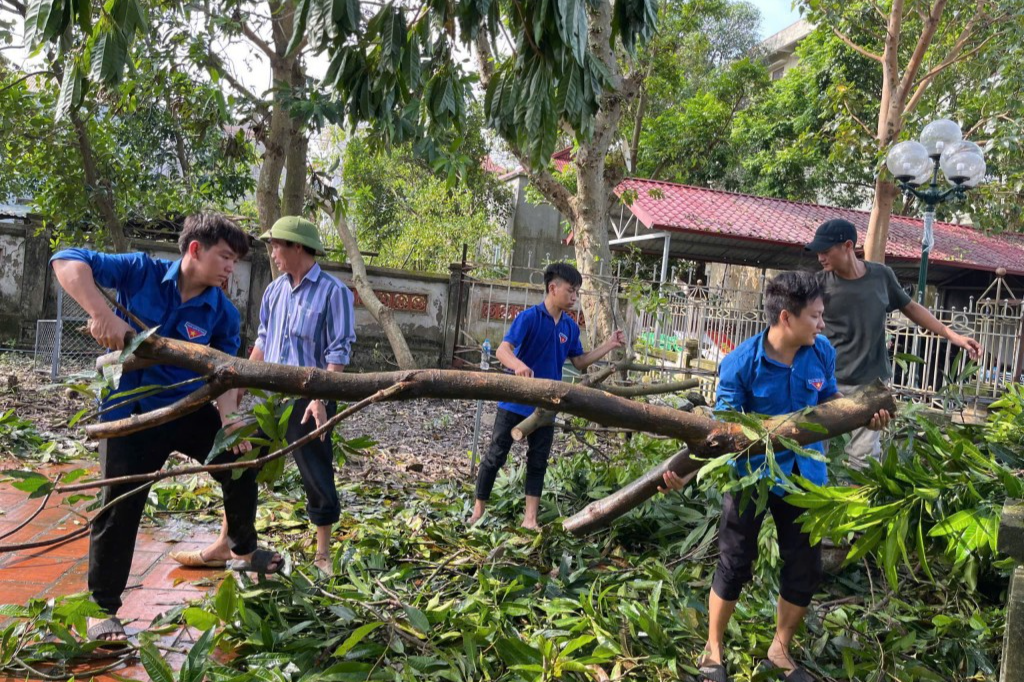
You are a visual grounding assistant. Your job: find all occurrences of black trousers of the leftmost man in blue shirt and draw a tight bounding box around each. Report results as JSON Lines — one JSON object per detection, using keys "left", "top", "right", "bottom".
{"left": 89, "top": 404, "right": 256, "bottom": 615}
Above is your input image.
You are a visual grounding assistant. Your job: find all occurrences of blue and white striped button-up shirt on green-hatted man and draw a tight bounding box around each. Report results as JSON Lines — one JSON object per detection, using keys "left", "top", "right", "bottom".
{"left": 256, "top": 263, "right": 355, "bottom": 370}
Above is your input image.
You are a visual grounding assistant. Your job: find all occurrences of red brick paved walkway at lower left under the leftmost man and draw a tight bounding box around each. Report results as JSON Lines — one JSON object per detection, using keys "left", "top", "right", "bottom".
{"left": 0, "top": 467, "right": 222, "bottom": 682}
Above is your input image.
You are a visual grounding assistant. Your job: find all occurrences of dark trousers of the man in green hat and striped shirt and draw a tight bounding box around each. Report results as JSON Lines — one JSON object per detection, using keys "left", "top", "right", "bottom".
{"left": 285, "top": 398, "right": 341, "bottom": 525}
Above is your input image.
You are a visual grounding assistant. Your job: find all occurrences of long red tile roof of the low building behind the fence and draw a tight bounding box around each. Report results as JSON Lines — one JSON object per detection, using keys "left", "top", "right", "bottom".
{"left": 615, "top": 178, "right": 1024, "bottom": 274}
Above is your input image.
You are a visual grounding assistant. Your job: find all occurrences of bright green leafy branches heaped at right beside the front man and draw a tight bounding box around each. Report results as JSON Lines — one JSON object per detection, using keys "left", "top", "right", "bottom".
{"left": 787, "top": 400, "right": 1024, "bottom": 590}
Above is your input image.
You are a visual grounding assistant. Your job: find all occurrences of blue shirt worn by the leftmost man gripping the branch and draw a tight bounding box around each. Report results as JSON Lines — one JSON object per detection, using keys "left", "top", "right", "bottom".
{"left": 50, "top": 249, "right": 242, "bottom": 421}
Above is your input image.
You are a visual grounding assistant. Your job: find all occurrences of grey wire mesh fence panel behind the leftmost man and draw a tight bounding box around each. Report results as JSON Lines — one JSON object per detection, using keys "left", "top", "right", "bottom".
{"left": 33, "top": 279, "right": 103, "bottom": 381}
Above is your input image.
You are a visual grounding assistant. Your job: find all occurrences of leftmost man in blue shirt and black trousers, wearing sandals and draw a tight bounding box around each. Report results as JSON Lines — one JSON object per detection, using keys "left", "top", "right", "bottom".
{"left": 50, "top": 214, "right": 284, "bottom": 641}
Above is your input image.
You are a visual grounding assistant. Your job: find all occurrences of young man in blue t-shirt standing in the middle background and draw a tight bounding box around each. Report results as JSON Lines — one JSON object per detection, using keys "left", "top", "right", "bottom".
{"left": 469, "top": 263, "right": 626, "bottom": 528}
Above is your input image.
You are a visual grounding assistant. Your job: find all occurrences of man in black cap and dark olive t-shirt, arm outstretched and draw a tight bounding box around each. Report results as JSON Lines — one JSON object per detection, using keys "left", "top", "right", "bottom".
{"left": 805, "top": 218, "right": 981, "bottom": 469}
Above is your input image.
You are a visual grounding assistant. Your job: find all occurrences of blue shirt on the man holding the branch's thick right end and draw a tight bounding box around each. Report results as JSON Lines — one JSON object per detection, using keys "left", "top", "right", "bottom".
{"left": 716, "top": 330, "right": 838, "bottom": 485}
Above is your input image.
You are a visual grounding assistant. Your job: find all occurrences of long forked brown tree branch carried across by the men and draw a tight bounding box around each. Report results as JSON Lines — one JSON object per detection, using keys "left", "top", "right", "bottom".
{"left": 86, "top": 335, "right": 896, "bottom": 458}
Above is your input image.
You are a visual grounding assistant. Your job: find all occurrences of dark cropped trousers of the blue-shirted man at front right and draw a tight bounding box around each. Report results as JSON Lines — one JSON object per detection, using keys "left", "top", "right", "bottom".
{"left": 712, "top": 493, "right": 823, "bottom": 606}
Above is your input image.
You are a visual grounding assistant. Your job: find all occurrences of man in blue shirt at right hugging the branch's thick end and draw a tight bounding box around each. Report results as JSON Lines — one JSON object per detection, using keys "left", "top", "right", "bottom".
{"left": 663, "top": 272, "right": 889, "bottom": 682}
